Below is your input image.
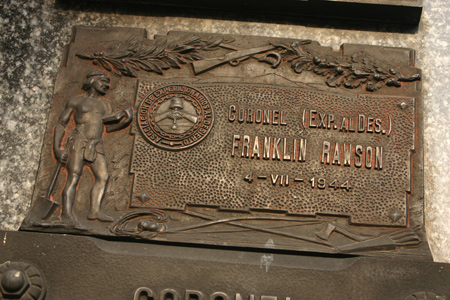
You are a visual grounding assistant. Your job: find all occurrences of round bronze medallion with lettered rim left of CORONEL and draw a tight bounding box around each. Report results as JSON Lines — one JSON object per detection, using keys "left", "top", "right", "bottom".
{"left": 138, "top": 85, "right": 214, "bottom": 151}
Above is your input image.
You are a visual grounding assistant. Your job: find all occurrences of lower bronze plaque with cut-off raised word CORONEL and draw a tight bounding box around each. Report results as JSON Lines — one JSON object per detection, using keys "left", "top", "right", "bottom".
{"left": 0, "top": 232, "right": 450, "bottom": 300}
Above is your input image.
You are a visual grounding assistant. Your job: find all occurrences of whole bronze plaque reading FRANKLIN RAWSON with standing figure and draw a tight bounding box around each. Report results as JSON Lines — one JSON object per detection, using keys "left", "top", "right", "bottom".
{"left": 22, "top": 27, "right": 430, "bottom": 259}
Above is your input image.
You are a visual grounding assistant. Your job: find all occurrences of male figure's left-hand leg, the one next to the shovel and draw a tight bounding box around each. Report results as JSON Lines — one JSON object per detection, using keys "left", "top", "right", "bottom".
{"left": 61, "top": 151, "right": 84, "bottom": 226}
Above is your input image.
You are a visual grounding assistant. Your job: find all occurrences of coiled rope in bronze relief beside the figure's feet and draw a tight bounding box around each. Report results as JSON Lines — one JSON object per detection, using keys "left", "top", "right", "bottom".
{"left": 110, "top": 209, "right": 168, "bottom": 238}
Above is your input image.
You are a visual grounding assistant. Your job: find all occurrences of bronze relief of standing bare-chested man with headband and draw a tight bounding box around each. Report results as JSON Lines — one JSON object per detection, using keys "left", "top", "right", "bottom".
{"left": 53, "top": 71, "right": 133, "bottom": 227}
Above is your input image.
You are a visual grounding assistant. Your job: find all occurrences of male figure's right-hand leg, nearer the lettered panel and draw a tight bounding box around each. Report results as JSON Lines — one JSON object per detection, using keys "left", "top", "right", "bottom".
{"left": 87, "top": 153, "right": 114, "bottom": 222}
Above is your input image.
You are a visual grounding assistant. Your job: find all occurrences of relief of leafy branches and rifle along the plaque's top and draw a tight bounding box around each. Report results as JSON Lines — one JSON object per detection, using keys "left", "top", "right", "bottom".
{"left": 77, "top": 36, "right": 421, "bottom": 92}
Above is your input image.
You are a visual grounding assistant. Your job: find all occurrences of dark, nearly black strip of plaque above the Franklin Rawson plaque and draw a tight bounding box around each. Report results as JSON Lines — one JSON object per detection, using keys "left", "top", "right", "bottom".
{"left": 55, "top": 0, "right": 422, "bottom": 33}
